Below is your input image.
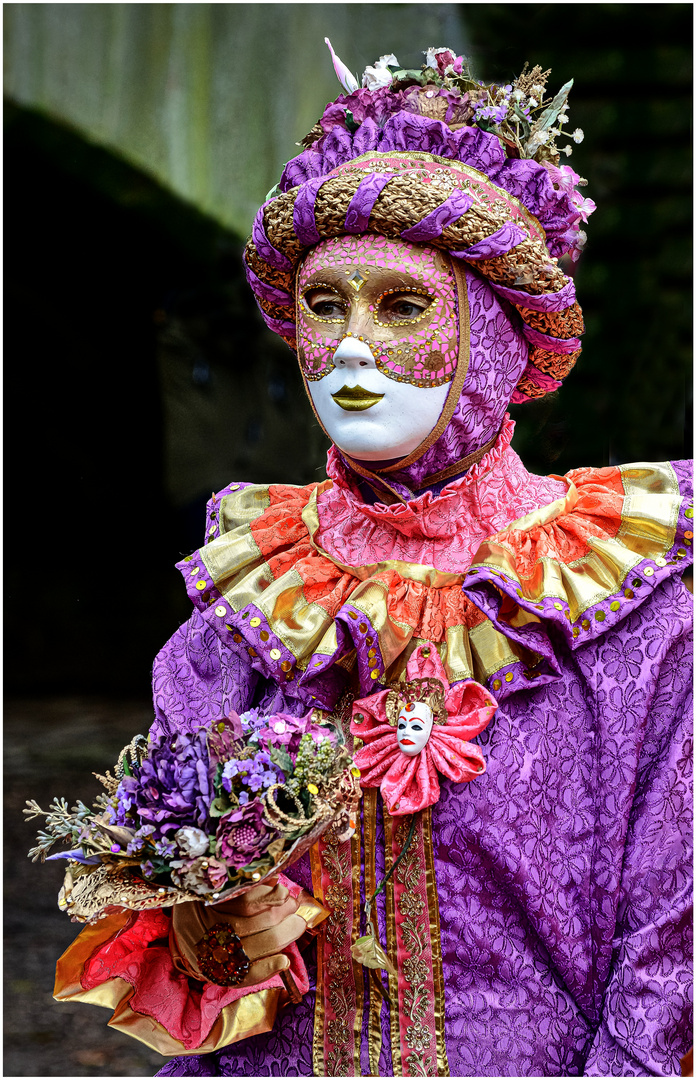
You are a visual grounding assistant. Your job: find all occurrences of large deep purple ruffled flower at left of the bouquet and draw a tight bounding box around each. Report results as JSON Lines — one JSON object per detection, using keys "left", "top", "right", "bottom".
{"left": 113, "top": 731, "right": 213, "bottom": 850}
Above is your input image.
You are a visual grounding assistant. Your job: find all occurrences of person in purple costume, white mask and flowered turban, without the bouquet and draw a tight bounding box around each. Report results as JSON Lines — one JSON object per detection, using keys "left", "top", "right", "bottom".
{"left": 52, "top": 50, "right": 693, "bottom": 1076}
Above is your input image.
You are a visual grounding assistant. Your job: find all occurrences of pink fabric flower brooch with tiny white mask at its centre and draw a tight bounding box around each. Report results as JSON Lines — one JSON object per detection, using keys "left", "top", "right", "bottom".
{"left": 350, "top": 642, "right": 498, "bottom": 814}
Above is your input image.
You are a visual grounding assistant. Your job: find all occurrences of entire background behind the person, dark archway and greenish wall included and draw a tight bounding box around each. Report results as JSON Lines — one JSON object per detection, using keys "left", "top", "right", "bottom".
{"left": 3, "top": 3, "right": 693, "bottom": 1076}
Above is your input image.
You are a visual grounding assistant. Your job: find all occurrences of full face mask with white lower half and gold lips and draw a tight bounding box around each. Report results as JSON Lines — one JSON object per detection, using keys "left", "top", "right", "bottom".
{"left": 297, "top": 235, "right": 458, "bottom": 461}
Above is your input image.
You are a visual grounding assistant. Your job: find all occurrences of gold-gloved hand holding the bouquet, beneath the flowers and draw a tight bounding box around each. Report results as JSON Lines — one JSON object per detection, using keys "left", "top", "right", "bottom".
{"left": 170, "top": 878, "right": 307, "bottom": 986}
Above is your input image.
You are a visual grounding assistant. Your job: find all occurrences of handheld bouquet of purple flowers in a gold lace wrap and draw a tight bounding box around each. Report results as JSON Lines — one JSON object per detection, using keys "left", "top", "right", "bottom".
{"left": 24, "top": 710, "right": 360, "bottom": 922}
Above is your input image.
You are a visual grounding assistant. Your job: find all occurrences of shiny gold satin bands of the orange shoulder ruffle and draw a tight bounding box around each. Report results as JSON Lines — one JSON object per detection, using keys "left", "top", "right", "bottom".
{"left": 196, "top": 462, "right": 681, "bottom": 695}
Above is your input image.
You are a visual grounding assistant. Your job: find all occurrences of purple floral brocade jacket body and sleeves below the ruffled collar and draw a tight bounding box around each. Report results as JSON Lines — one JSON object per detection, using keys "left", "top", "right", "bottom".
{"left": 153, "top": 451, "right": 693, "bottom": 1077}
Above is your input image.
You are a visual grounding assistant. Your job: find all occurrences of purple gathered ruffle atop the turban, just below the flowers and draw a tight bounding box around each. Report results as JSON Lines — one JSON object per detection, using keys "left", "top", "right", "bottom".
{"left": 279, "top": 111, "right": 580, "bottom": 257}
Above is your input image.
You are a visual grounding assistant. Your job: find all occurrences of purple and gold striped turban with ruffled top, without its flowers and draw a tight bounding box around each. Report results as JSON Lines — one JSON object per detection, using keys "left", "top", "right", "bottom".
{"left": 244, "top": 111, "right": 584, "bottom": 402}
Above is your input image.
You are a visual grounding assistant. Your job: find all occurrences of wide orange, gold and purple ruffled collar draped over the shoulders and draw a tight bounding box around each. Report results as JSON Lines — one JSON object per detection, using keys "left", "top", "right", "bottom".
{"left": 178, "top": 446, "right": 694, "bottom": 708}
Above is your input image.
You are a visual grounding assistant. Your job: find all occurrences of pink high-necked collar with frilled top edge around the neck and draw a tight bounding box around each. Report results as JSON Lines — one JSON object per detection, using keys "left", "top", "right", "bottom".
{"left": 317, "top": 416, "right": 567, "bottom": 573}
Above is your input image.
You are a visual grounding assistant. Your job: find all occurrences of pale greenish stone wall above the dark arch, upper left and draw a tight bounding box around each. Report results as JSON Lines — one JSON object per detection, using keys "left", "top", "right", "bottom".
{"left": 4, "top": 3, "right": 463, "bottom": 235}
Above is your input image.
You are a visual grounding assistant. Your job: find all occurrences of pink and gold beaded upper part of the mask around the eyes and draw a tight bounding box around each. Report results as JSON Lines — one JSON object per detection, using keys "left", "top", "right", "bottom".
{"left": 297, "top": 234, "right": 459, "bottom": 387}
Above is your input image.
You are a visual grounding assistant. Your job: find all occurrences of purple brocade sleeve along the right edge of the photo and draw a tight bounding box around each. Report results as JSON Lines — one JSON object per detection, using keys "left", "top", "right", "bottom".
{"left": 585, "top": 613, "right": 693, "bottom": 1076}
